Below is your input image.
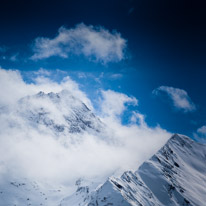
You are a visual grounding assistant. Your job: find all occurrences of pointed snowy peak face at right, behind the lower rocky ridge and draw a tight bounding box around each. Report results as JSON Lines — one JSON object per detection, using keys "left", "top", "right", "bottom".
{"left": 137, "top": 135, "right": 206, "bottom": 206}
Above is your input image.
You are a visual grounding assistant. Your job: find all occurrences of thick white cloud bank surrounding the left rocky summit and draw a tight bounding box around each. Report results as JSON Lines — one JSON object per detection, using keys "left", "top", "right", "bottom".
{"left": 0, "top": 69, "right": 171, "bottom": 187}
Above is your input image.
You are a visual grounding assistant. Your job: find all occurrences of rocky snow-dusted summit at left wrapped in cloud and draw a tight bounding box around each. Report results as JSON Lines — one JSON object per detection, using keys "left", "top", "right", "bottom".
{"left": 17, "top": 90, "right": 103, "bottom": 133}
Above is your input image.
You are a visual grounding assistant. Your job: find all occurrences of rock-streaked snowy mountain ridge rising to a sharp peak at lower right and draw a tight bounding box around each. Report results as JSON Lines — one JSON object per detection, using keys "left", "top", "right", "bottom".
{"left": 60, "top": 134, "right": 206, "bottom": 206}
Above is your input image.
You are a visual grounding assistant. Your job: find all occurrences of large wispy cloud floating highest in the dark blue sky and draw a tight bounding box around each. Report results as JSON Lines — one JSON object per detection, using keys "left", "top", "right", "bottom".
{"left": 31, "top": 23, "right": 126, "bottom": 63}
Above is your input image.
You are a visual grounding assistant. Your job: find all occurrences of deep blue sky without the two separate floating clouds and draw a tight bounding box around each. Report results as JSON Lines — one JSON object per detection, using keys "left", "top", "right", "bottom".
{"left": 0, "top": 0, "right": 206, "bottom": 136}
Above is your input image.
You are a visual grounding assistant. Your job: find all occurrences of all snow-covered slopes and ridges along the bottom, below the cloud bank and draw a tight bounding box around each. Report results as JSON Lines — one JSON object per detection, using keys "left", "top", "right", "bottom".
{"left": 0, "top": 134, "right": 206, "bottom": 206}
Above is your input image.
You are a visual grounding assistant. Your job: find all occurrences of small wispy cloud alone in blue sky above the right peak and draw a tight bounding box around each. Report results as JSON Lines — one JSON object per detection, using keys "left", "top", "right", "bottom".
{"left": 153, "top": 86, "right": 196, "bottom": 112}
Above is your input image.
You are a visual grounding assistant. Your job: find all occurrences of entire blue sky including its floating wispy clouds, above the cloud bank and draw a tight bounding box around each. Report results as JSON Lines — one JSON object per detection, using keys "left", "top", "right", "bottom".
{"left": 0, "top": 0, "right": 206, "bottom": 138}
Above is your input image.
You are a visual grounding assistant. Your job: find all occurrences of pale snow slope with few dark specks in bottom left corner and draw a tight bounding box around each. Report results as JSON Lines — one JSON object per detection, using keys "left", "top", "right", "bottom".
{"left": 0, "top": 178, "right": 69, "bottom": 206}
